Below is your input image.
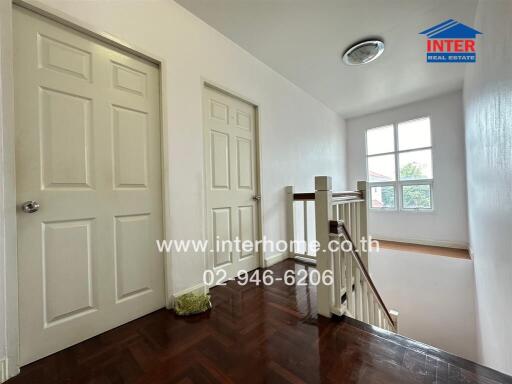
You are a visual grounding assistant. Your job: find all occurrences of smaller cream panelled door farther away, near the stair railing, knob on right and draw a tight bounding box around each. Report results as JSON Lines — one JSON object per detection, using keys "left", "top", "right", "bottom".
{"left": 203, "top": 87, "right": 259, "bottom": 282}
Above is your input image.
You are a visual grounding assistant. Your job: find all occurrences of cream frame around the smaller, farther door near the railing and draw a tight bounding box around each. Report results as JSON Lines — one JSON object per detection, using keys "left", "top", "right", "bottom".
{"left": 200, "top": 77, "right": 265, "bottom": 282}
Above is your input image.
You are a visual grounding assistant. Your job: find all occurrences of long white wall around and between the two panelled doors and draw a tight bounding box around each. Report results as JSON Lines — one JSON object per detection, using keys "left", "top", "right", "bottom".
{"left": 18, "top": 0, "right": 345, "bottom": 292}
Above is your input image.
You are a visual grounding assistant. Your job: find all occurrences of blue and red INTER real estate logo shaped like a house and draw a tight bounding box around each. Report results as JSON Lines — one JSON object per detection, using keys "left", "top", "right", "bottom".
{"left": 420, "top": 19, "right": 482, "bottom": 63}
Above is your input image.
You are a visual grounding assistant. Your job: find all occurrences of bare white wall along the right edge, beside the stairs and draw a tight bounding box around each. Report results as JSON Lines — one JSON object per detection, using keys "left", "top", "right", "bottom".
{"left": 464, "top": 0, "right": 512, "bottom": 374}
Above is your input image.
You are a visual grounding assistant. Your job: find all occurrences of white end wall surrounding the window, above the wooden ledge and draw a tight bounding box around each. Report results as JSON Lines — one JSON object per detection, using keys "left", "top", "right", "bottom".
{"left": 347, "top": 91, "right": 468, "bottom": 247}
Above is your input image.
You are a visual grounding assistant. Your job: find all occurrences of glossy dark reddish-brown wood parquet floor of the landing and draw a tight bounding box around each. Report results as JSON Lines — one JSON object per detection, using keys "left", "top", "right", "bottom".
{"left": 8, "top": 260, "right": 512, "bottom": 384}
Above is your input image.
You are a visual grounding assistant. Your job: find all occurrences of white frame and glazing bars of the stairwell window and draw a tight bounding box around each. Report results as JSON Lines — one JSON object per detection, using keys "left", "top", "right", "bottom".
{"left": 365, "top": 116, "right": 434, "bottom": 213}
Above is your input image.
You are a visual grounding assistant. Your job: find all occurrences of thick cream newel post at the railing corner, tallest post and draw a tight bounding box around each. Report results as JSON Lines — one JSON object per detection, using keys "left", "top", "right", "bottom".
{"left": 315, "top": 176, "right": 334, "bottom": 317}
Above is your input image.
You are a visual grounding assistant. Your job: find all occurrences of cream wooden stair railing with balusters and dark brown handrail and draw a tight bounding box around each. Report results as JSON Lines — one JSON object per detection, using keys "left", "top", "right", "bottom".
{"left": 287, "top": 176, "right": 398, "bottom": 332}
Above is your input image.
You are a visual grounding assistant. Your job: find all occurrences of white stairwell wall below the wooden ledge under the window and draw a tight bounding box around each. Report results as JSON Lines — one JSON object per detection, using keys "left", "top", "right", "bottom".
{"left": 369, "top": 249, "right": 477, "bottom": 361}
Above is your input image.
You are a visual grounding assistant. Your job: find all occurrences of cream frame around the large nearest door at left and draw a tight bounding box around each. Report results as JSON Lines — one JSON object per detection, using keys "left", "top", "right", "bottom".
{"left": 0, "top": 0, "right": 174, "bottom": 381}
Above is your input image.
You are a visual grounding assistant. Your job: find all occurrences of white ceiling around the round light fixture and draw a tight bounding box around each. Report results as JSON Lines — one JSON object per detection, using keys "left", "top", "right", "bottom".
{"left": 177, "top": 0, "right": 477, "bottom": 117}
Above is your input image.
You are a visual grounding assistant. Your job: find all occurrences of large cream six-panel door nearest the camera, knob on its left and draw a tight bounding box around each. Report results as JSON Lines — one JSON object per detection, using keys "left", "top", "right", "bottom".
{"left": 14, "top": 7, "right": 165, "bottom": 364}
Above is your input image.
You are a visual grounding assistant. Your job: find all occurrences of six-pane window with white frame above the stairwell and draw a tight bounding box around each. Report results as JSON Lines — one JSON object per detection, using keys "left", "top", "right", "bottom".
{"left": 366, "top": 117, "right": 434, "bottom": 211}
